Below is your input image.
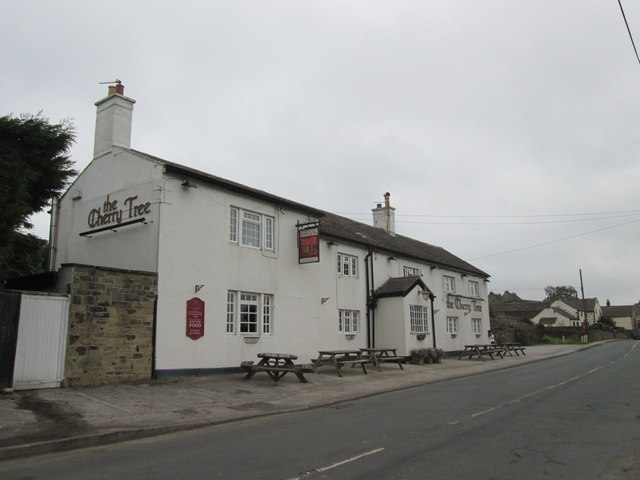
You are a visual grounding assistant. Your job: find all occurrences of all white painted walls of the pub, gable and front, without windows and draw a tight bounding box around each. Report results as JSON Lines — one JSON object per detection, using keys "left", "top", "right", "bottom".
{"left": 56, "top": 152, "right": 489, "bottom": 370}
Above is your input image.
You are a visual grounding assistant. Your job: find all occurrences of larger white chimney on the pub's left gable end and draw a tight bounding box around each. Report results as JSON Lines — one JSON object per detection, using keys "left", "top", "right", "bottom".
{"left": 93, "top": 80, "right": 136, "bottom": 158}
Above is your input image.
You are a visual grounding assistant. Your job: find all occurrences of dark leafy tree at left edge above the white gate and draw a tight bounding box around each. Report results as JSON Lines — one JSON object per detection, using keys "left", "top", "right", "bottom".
{"left": 0, "top": 114, "right": 76, "bottom": 280}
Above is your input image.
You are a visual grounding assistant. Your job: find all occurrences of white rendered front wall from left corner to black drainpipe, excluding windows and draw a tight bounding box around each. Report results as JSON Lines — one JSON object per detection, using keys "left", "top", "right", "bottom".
{"left": 156, "top": 178, "right": 366, "bottom": 370}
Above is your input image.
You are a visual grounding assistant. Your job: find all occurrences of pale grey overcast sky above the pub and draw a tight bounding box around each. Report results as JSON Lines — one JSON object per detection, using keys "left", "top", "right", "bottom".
{"left": 5, "top": 0, "right": 640, "bottom": 305}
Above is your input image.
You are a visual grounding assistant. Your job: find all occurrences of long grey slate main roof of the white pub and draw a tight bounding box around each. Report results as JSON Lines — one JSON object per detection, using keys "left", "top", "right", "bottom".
{"left": 127, "top": 149, "right": 490, "bottom": 278}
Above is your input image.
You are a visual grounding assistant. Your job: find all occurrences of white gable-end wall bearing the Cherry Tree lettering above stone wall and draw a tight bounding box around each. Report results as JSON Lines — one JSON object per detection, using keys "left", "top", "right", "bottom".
{"left": 53, "top": 149, "right": 161, "bottom": 271}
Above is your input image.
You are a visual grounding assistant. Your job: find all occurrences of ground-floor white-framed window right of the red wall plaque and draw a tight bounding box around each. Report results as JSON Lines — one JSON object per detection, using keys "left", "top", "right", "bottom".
{"left": 226, "top": 291, "right": 273, "bottom": 335}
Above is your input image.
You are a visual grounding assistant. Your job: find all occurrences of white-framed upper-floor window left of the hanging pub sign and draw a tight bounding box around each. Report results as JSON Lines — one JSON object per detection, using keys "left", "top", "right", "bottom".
{"left": 229, "top": 207, "right": 274, "bottom": 250}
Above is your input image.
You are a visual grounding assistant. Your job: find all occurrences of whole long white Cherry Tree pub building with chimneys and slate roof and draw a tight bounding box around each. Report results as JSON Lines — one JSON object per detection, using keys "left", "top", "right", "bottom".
{"left": 50, "top": 83, "right": 489, "bottom": 377}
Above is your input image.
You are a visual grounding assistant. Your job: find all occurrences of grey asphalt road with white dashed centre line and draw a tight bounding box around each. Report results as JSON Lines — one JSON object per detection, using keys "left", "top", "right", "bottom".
{"left": 0, "top": 341, "right": 640, "bottom": 480}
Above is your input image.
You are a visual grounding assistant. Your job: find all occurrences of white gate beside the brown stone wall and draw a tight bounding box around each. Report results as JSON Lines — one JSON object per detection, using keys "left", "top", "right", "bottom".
{"left": 13, "top": 294, "right": 69, "bottom": 390}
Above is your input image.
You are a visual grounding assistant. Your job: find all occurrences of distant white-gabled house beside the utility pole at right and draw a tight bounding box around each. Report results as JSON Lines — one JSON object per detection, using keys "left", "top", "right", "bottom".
{"left": 531, "top": 298, "right": 602, "bottom": 327}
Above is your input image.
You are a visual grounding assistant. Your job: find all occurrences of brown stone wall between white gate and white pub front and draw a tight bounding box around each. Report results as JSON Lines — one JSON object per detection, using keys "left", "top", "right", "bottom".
{"left": 62, "top": 265, "right": 157, "bottom": 386}
